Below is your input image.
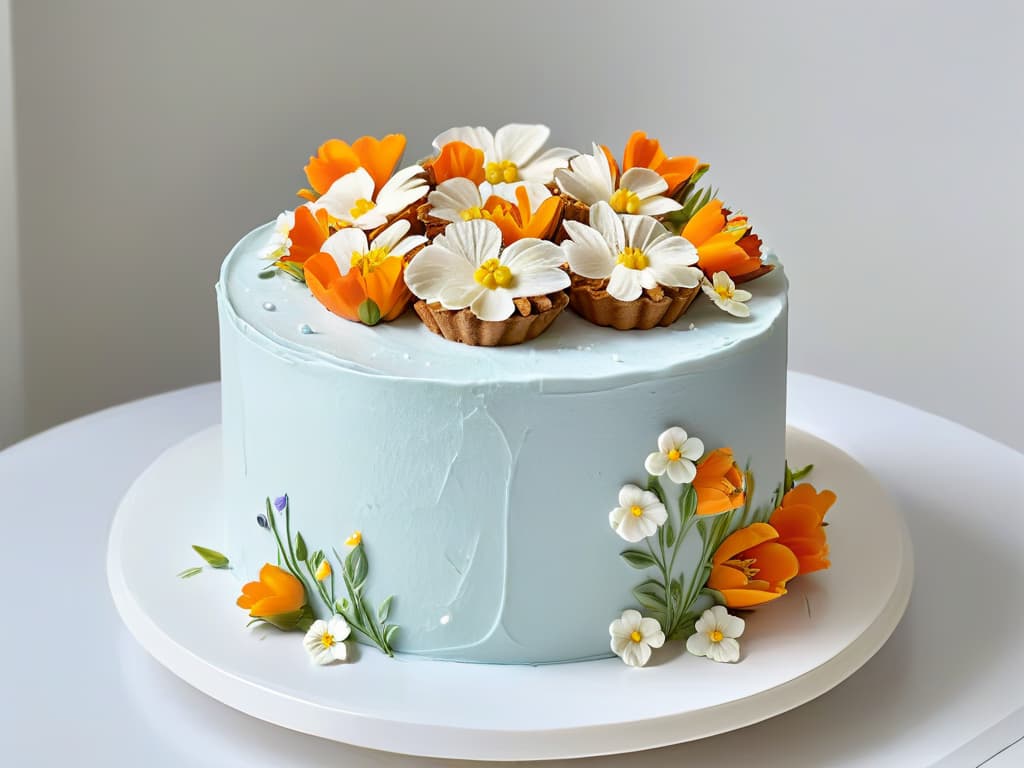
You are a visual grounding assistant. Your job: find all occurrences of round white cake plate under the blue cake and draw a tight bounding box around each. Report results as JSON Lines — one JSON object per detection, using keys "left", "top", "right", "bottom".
{"left": 108, "top": 426, "right": 913, "bottom": 761}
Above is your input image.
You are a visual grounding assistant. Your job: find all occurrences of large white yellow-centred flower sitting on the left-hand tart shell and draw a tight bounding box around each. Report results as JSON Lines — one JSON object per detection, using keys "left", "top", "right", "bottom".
{"left": 406, "top": 219, "right": 569, "bottom": 321}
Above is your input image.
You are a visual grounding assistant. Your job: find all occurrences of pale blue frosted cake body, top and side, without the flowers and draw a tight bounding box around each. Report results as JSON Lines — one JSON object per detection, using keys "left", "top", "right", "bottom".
{"left": 217, "top": 225, "right": 786, "bottom": 664}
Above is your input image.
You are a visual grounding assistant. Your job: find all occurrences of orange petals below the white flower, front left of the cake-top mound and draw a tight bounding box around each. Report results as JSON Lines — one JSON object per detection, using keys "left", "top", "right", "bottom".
{"left": 305, "top": 253, "right": 413, "bottom": 322}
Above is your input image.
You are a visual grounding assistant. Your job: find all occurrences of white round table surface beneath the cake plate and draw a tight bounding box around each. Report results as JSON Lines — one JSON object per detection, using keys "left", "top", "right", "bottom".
{"left": 0, "top": 374, "right": 1024, "bottom": 768}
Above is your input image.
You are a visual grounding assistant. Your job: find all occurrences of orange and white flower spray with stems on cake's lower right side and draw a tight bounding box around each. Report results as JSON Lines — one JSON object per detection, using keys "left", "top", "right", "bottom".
{"left": 608, "top": 427, "right": 836, "bottom": 667}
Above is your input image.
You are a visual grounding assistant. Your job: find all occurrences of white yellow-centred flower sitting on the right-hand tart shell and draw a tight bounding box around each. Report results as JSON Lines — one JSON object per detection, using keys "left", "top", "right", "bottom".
{"left": 562, "top": 201, "right": 703, "bottom": 301}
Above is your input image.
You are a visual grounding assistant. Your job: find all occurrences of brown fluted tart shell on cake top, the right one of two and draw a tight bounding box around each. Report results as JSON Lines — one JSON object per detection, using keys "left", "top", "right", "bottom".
{"left": 569, "top": 272, "right": 700, "bottom": 331}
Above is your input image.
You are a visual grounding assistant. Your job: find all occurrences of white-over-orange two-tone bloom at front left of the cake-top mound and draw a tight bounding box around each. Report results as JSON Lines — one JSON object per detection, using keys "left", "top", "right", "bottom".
{"left": 305, "top": 219, "right": 426, "bottom": 325}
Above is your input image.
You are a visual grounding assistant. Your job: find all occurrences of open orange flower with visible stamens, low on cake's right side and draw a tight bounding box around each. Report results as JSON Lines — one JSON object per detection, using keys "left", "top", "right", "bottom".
{"left": 708, "top": 522, "right": 800, "bottom": 608}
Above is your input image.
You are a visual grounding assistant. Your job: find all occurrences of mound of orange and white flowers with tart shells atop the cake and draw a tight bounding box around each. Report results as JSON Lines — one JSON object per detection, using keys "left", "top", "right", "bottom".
{"left": 256, "top": 124, "right": 772, "bottom": 344}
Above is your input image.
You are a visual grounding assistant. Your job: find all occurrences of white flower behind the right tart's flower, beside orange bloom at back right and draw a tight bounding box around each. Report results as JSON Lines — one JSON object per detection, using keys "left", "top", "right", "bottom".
{"left": 555, "top": 144, "right": 682, "bottom": 216}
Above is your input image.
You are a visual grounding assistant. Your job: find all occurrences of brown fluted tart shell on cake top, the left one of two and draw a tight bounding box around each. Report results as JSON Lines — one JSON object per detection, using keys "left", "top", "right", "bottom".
{"left": 413, "top": 291, "right": 569, "bottom": 347}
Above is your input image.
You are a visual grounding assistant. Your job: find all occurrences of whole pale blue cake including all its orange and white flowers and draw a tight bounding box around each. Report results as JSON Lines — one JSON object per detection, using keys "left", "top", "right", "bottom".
{"left": 197, "top": 125, "right": 835, "bottom": 667}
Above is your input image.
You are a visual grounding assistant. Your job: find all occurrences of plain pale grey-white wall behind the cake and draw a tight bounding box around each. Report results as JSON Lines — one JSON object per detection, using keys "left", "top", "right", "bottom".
{"left": 8, "top": 0, "right": 1024, "bottom": 450}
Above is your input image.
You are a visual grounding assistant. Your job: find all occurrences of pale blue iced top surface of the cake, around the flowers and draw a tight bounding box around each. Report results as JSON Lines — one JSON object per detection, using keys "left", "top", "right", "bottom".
{"left": 217, "top": 224, "right": 786, "bottom": 387}
